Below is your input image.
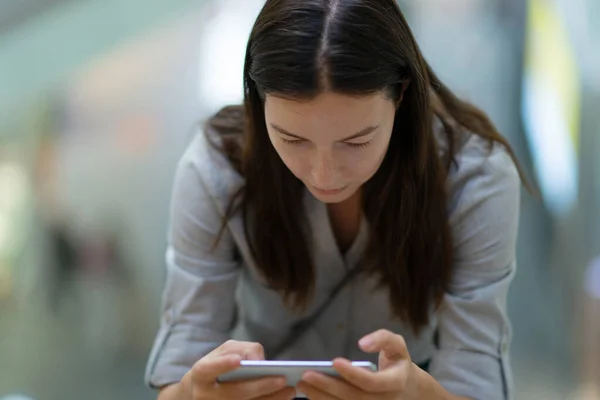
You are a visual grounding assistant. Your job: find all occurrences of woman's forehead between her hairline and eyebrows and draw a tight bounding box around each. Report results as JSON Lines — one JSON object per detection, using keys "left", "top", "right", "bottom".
{"left": 265, "top": 92, "right": 394, "bottom": 138}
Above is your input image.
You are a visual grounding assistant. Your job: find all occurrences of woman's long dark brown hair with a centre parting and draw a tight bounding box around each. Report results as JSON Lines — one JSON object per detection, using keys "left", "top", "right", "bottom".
{"left": 208, "top": 0, "right": 516, "bottom": 332}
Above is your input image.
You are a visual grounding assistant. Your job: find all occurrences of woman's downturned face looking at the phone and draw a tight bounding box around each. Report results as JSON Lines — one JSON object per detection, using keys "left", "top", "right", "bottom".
{"left": 265, "top": 92, "right": 396, "bottom": 203}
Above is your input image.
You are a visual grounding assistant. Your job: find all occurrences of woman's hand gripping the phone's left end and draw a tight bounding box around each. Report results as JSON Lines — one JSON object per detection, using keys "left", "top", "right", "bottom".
{"left": 173, "top": 340, "right": 296, "bottom": 400}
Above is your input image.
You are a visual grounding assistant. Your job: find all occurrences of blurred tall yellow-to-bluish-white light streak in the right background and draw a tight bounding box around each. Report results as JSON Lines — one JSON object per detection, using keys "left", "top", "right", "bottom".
{"left": 522, "top": 0, "right": 581, "bottom": 216}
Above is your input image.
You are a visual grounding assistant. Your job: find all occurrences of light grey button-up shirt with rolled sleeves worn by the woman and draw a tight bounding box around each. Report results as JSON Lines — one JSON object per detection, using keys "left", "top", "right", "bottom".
{"left": 146, "top": 126, "right": 520, "bottom": 400}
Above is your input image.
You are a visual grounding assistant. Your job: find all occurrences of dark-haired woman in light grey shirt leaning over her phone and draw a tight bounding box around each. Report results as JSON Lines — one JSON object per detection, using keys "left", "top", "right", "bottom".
{"left": 146, "top": 0, "right": 520, "bottom": 400}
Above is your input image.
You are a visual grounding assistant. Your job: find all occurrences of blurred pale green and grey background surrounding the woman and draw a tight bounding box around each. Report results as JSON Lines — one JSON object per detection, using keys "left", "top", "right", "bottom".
{"left": 0, "top": 0, "right": 600, "bottom": 400}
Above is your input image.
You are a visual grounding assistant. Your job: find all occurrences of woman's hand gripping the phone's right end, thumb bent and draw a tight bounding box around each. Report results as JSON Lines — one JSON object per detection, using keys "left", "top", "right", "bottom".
{"left": 297, "top": 330, "right": 419, "bottom": 400}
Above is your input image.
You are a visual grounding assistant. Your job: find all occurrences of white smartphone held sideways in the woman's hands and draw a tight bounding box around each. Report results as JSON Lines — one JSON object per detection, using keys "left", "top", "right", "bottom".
{"left": 217, "top": 360, "right": 377, "bottom": 386}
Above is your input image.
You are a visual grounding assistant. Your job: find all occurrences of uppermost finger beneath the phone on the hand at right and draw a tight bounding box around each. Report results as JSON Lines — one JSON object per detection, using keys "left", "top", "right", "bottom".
{"left": 333, "top": 359, "right": 405, "bottom": 393}
